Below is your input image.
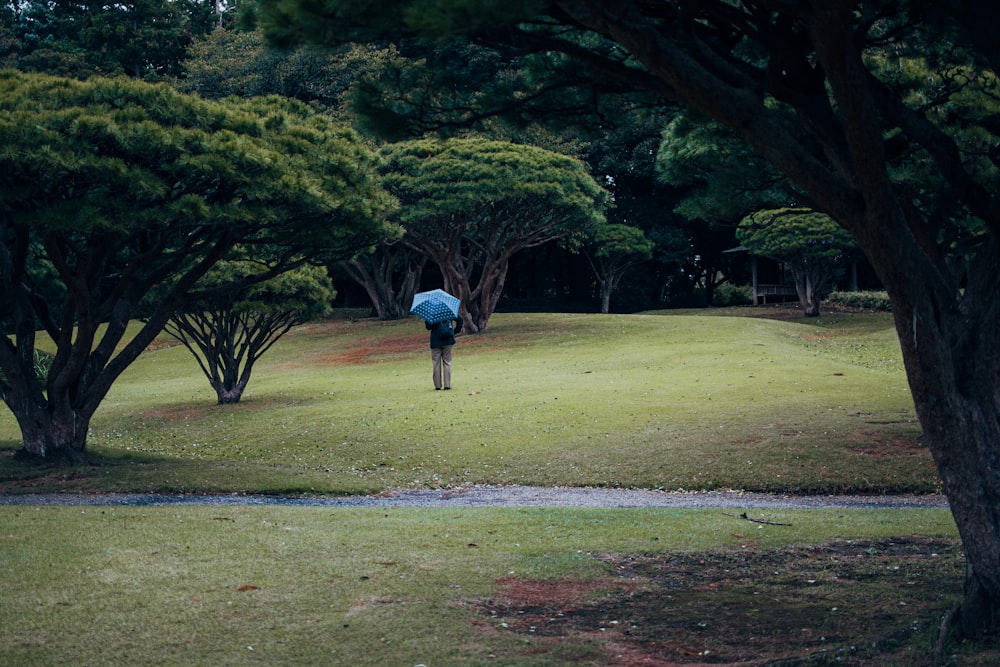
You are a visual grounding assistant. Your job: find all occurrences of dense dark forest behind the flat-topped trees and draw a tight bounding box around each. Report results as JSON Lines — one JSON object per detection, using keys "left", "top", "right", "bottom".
{"left": 0, "top": 0, "right": 878, "bottom": 317}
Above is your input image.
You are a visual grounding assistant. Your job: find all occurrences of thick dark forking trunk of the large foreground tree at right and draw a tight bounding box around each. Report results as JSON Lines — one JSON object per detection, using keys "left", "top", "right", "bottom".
{"left": 804, "top": 2, "right": 1000, "bottom": 637}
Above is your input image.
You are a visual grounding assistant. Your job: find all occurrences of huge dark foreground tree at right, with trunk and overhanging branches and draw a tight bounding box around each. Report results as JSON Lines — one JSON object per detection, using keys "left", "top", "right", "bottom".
{"left": 260, "top": 0, "right": 1000, "bottom": 636}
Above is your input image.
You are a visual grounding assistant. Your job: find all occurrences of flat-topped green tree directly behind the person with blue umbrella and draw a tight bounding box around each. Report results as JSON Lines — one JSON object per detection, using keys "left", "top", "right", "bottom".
{"left": 382, "top": 139, "right": 607, "bottom": 333}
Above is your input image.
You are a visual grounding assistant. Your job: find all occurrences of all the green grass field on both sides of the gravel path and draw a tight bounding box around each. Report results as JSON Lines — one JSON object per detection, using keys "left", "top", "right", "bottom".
{"left": 0, "top": 310, "right": 975, "bottom": 667}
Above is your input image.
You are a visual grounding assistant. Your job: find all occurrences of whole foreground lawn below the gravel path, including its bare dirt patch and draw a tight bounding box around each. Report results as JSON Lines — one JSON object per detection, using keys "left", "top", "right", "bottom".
{"left": 0, "top": 506, "right": 962, "bottom": 667}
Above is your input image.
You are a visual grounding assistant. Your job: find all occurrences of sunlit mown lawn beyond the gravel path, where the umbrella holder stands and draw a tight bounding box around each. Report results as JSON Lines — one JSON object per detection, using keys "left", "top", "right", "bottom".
{"left": 0, "top": 313, "right": 937, "bottom": 494}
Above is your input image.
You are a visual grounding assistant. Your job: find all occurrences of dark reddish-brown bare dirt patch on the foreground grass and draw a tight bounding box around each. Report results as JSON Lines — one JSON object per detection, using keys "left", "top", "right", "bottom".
{"left": 478, "top": 537, "right": 1000, "bottom": 667}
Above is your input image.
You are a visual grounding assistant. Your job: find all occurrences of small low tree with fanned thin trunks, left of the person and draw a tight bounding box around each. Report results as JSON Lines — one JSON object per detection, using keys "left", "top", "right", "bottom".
{"left": 165, "top": 259, "right": 336, "bottom": 405}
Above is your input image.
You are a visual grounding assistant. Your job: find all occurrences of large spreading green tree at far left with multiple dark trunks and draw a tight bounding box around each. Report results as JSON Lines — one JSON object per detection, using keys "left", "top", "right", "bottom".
{"left": 0, "top": 71, "right": 393, "bottom": 460}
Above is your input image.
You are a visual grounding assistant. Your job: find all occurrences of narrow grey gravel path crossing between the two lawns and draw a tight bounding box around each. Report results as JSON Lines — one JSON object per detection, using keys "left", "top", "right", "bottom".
{"left": 0, "top": 486, "right": 948, "bottom": 509}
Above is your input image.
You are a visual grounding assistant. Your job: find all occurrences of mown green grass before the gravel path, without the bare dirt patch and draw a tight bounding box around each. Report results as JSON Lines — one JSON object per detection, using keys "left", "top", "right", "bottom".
{"left": 0, "top": 506, "right": 958, "bottom": 666}
